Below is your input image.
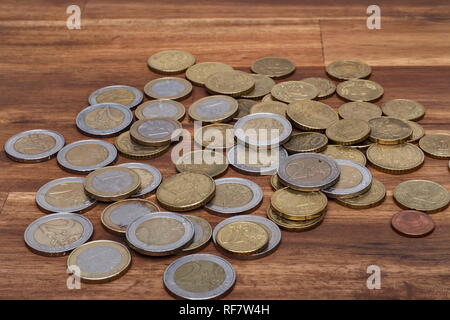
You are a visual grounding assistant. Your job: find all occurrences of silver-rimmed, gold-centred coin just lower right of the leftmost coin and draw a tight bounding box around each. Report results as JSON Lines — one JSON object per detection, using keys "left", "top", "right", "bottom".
{"left": 57, "top": 140, "right": 117, "bottom": 174}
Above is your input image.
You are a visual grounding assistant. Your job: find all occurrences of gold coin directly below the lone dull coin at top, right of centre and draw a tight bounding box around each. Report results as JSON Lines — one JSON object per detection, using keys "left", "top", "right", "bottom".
{"left": 270, "top": 81, "right": 319, "bottom": 103}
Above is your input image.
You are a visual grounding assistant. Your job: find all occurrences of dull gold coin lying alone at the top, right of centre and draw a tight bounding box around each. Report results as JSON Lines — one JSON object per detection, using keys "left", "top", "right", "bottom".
{"left": 251, "top": 57, "right": 295, "bottom": 79}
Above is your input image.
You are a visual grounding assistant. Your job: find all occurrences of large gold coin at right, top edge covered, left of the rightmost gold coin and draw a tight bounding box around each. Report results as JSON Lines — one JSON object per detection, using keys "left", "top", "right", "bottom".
{"left": 366, "top": 143, "right": 425, "bottom": 174}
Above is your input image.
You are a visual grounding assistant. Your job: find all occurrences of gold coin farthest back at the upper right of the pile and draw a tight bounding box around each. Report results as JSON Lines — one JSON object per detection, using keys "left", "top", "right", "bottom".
{"left": 326, "top": 60, "right": 372, "bottom": 80}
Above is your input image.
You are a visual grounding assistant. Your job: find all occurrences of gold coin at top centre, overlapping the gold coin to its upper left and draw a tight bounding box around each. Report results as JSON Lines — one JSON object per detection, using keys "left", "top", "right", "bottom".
{"left": 205, "top": 70, "right": 255, "bottom": 97}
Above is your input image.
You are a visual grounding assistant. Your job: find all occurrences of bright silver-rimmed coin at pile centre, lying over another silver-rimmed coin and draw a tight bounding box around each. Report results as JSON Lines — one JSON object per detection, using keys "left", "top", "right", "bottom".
{"left": 234, "top": 112, "right": 292, "bottom": 148}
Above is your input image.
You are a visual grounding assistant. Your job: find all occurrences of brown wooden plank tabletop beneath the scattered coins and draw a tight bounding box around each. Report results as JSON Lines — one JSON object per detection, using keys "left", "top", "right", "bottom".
{"left": 0, "top": 0, "right": 450, "bottom": 299}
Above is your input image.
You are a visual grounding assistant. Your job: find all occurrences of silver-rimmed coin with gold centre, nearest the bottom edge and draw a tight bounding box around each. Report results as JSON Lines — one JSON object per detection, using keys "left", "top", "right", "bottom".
{"left": 164, "top": 254, "right": 236, "bottom": 300}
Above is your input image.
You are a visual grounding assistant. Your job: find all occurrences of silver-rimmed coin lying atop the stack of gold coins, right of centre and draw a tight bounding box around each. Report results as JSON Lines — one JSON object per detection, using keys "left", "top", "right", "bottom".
{"left": 278, "top": 153, "right": 340, "bottom": 191}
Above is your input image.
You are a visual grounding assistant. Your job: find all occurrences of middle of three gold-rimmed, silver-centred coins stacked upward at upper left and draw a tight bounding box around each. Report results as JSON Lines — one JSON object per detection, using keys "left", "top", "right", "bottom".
{"left": 134, "top": 99, "right": 186, "bottom": 121}
